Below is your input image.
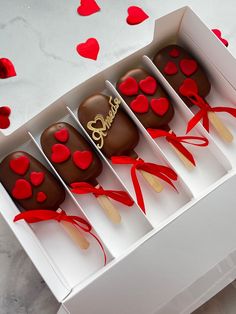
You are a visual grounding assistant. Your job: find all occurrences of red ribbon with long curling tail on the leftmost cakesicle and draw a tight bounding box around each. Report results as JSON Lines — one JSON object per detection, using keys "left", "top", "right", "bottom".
{"left": 14, "top": 209, "right": 107, "bottom": 265}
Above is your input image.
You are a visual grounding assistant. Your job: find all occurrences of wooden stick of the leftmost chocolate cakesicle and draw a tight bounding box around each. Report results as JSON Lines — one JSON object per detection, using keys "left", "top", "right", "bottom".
{"left": 57, "top": 208, "right": 89, "bottom": 250}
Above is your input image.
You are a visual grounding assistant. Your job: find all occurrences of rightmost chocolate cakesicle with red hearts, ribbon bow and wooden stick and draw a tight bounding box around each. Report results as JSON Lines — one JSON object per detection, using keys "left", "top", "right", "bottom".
{"left": 153, "top": 45, "right": 236, "bottom": 142}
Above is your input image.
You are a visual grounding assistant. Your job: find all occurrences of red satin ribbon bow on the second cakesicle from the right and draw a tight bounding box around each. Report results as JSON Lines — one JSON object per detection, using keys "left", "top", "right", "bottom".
{"left": 147, "top": 129, "right": 209, "bottom": 166}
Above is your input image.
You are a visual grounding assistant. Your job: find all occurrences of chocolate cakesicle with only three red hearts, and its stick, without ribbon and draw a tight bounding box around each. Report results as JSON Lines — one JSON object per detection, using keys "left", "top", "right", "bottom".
{"left": 41, "top": 122, "right": 127, "bottom": 223}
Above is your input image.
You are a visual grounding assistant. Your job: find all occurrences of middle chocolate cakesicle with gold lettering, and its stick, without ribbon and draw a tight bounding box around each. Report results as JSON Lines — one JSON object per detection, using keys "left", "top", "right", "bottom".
{"left": 78, "top": 93, "right": 178, "bottom": 211}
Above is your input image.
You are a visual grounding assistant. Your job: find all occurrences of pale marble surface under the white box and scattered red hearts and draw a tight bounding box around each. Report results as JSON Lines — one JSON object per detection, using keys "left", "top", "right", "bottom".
{"left": 0, "top": 0, "right": 236, "bottom": 314}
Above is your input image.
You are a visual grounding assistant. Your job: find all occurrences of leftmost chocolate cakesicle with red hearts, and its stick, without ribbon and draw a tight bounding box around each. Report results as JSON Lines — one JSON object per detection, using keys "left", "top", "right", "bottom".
{"left": 0, "top": 151, "right": 89, "bottom": 249}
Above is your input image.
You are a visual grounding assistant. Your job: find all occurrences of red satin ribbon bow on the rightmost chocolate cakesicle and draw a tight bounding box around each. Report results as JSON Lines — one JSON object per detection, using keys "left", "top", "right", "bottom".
{"left": 181, "top": 86, "right": 236, "bottom": 133}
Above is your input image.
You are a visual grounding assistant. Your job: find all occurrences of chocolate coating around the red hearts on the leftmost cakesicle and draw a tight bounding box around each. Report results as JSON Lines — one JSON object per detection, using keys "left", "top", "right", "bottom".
{"left": 0, "top": 151, "right": 66, "bottom": 211}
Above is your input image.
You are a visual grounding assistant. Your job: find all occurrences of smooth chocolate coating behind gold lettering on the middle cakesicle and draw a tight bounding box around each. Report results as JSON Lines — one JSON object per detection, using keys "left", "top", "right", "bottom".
{"left": 78, "top": 94, "right": 139, "bottom": 158}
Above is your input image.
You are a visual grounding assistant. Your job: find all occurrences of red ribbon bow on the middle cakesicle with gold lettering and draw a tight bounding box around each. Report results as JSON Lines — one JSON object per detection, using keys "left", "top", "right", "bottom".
{"left": 111, "top": 156, "right": 177, "bottom": 213}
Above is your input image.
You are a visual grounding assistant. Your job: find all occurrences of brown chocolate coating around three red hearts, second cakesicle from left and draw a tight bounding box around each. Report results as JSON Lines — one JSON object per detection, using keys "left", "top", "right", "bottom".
{"left": 41, "top": 122, "right": 102, "bottom": 185}
